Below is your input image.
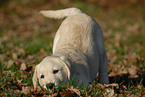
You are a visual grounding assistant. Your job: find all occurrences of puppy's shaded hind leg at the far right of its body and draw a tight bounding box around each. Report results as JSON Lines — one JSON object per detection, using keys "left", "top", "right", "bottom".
{"left": 95, "top": 24, "right": 109, "bottom": 84}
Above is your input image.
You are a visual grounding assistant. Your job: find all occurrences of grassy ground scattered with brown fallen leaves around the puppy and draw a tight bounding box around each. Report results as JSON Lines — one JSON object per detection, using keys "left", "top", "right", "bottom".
{"left": 0, "top": 0, "right": 145, "bottom": 97}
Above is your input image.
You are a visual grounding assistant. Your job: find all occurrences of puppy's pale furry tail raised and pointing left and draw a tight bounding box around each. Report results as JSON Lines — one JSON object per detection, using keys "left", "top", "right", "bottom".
{"left": 40, "top": 8, "right": 82, "bottom": 19}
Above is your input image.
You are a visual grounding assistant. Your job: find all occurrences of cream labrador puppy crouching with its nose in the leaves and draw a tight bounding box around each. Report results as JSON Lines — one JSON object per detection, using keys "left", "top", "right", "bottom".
{"left": 33, "top": 8, "right": 109, "bottom": 89}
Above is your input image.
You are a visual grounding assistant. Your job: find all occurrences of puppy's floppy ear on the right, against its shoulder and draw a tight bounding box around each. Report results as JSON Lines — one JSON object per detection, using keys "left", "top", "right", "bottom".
{"left": 60, "top": 56, "right": 70, "bottom": 79}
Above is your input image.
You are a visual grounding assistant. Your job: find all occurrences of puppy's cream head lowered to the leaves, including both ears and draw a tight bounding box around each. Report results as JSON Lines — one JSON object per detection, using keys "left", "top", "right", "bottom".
{"left": 33, "top": 57, "right": 70, "bottom": 89}
